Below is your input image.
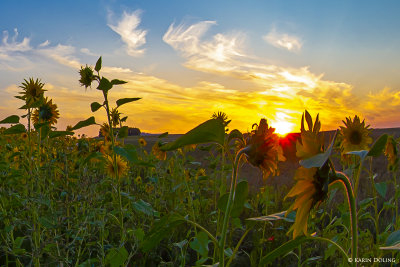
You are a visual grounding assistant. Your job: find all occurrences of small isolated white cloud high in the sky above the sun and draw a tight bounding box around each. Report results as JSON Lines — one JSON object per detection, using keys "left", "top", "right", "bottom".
{"left": 263, "top": 28, "right": 303, "bottom": 52}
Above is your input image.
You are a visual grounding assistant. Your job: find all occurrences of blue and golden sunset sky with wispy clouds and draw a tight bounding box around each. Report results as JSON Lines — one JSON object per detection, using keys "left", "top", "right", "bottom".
{"left": 0, "top": 0, "right": 400, "bottom": 136}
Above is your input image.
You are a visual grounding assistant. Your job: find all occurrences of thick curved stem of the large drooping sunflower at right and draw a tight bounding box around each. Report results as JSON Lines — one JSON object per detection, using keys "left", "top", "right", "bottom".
{"left": 334, "top": 172, "right": 358, "bottom": 266}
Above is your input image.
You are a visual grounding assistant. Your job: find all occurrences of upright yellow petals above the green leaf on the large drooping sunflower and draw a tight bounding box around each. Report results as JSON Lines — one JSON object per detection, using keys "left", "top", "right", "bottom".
{"left": 296, "top": 110, "right": 324, "bottom": 159}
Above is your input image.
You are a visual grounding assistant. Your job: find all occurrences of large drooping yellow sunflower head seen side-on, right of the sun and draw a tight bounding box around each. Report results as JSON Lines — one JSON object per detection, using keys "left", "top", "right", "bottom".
{"left": 285, "top": 111, "right": 329, "bottom": 239}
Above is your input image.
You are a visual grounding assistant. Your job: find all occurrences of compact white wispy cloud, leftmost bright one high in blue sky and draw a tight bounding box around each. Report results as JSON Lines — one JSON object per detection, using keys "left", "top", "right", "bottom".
{"left": 108, "top": 10, "right": 147, "bottom": 57}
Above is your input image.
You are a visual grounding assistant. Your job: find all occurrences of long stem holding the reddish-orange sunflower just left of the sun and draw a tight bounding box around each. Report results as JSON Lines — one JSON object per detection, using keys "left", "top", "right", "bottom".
{"left": 219, "top": 147, "right": 249, "bottom": 267}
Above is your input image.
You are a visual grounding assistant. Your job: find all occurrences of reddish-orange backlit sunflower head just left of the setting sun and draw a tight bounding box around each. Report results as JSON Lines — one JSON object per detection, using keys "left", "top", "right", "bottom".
{"left": 239, "top": 119, "right": 286, "bottom": 179}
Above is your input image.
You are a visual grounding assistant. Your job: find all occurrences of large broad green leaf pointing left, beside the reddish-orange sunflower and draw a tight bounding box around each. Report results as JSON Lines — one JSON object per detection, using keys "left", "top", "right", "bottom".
{"left": 160, "top": 119, "right": 225, "bottom": 151}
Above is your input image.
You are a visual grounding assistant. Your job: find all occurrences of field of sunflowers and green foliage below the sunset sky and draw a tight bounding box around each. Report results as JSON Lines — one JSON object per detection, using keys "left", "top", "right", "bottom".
{"left": 0, "top": 58, "right": 400, "bottom": 266}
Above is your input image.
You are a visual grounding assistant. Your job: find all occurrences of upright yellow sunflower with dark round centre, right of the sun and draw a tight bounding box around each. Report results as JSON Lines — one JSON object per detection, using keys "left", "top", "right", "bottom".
{"left": 340, "top": 115, "right": 372, "bottom": 155}
